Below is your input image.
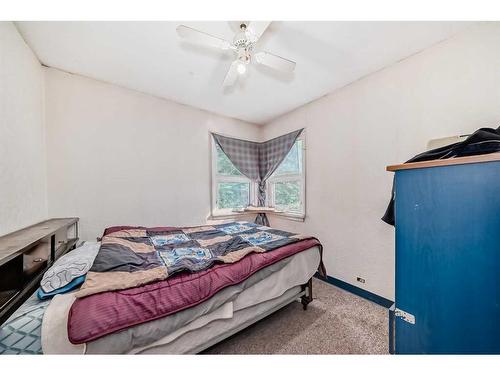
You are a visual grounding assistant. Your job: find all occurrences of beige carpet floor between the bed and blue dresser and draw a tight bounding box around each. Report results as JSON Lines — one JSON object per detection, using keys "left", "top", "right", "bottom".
{"left": 205, "top": 279, "right": 389, "bottom": 354}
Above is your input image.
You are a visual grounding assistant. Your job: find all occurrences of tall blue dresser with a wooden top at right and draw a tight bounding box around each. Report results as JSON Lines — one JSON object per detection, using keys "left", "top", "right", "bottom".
{"left": 387, "top": 154, "right": 500, "bottom": 354}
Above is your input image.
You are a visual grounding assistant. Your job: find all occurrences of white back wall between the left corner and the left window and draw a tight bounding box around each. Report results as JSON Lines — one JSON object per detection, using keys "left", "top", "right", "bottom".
{"left": 45, "top": 69, "right": 260, "bottom": 240}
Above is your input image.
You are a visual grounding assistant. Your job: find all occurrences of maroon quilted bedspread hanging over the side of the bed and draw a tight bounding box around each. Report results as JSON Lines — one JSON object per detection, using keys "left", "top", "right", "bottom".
{"left": 68, "top": 239, "right": 324, "bottom": 344}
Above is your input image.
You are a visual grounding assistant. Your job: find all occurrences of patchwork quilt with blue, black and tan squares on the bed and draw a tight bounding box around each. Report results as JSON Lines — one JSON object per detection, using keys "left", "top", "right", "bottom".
{"left": 76, "top": 221, "right": 318, "bottom": 298}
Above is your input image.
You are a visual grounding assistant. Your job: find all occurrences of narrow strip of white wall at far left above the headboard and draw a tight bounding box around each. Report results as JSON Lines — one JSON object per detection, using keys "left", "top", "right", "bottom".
{"left": 0, "top": 22, "right": 47, "bottom": 235}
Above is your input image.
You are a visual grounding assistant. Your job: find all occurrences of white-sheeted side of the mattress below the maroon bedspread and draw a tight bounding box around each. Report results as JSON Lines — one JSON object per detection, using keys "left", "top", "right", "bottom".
{"left": 42, "top": 246, "right": 320, "bottom": 354}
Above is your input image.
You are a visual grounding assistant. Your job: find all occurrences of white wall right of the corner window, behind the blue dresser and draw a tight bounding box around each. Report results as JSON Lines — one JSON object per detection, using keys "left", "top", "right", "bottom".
{"left": 263, "top": 23, "right": 500, "bottom": 300}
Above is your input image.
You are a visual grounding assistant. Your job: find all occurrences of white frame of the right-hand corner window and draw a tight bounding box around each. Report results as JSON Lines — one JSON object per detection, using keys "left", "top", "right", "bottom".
{"left": 266, "top": 134, "right": 306, "bottom": 221}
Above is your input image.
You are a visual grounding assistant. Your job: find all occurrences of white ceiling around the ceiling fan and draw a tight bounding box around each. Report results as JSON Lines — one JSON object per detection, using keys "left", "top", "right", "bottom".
{"left": 17, "top": 21, "right": 470, "bottom": 124}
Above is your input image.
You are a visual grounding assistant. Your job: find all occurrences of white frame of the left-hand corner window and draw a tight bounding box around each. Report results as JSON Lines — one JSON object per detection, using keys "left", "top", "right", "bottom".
{"left": 210, "top": 137, "right": 257, "bottom": 218}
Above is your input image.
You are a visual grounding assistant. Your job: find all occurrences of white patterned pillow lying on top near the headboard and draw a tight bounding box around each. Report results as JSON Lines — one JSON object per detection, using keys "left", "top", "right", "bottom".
{"left": 40, "top": 242, "right": 101, "bottom": 293}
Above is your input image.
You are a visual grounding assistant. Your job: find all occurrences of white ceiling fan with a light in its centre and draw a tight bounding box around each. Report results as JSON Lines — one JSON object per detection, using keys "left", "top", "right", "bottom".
{"left": 177, "top": 21, "right": 296, "bottom": 87}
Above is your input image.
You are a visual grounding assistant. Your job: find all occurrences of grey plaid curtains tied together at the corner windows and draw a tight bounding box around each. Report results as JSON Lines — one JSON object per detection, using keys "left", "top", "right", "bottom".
{"left": 212, "top": 129, "right": 304, "bottom": 226}
